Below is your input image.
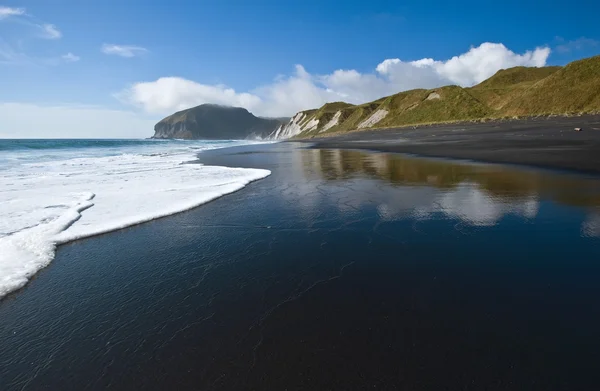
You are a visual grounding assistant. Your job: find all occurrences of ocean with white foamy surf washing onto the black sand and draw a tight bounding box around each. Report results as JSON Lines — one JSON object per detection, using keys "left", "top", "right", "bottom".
{"left": 0, "top": 139, "right": 270, "bottom": 298}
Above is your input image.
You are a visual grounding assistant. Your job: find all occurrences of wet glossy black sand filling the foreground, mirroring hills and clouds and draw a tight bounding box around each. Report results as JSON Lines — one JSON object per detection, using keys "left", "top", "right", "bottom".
{"left": 0, "top": 143, "right": 600, "bottom": 391}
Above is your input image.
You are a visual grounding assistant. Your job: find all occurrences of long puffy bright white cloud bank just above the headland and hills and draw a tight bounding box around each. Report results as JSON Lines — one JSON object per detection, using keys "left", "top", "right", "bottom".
{"left": 118, "top": 43, "right": 550, "bottom": 116}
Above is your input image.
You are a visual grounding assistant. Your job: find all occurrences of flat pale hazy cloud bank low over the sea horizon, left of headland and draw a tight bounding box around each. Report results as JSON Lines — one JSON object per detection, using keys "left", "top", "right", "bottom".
{"left": 0, "top": 103, "right": 158, "bottom": 138}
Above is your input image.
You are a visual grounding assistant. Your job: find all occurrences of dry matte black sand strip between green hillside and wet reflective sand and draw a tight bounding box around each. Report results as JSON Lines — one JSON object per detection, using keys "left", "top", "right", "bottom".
{"left": 311, "top": 115, "right": 600, "bottom": 173}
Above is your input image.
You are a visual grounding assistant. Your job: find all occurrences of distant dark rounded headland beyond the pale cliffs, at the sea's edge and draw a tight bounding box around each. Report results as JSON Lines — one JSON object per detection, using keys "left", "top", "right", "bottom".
{"left": 152, "top": 104, "right": 289, "bottom": 140}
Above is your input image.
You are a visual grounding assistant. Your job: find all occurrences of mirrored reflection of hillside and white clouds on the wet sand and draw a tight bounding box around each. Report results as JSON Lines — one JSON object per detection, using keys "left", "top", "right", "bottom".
{"left": 302, "top": 149, "right": 600, "bottom": 231}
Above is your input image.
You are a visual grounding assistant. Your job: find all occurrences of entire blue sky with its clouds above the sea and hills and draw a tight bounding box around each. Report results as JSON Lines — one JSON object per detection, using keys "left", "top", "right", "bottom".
{"left": 0, "top": 0, "right": 600, "bottom": 137}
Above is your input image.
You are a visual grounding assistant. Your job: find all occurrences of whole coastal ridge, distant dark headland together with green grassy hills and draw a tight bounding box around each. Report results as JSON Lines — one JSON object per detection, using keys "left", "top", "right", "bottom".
{"left": 153, "top": 56, "right": 600, "bottom": 140}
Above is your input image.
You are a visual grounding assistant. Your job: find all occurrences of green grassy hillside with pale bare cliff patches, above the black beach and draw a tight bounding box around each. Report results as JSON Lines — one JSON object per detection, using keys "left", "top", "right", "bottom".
{"left": 284, "top": 56, "right": 600, "bottom": 137}
